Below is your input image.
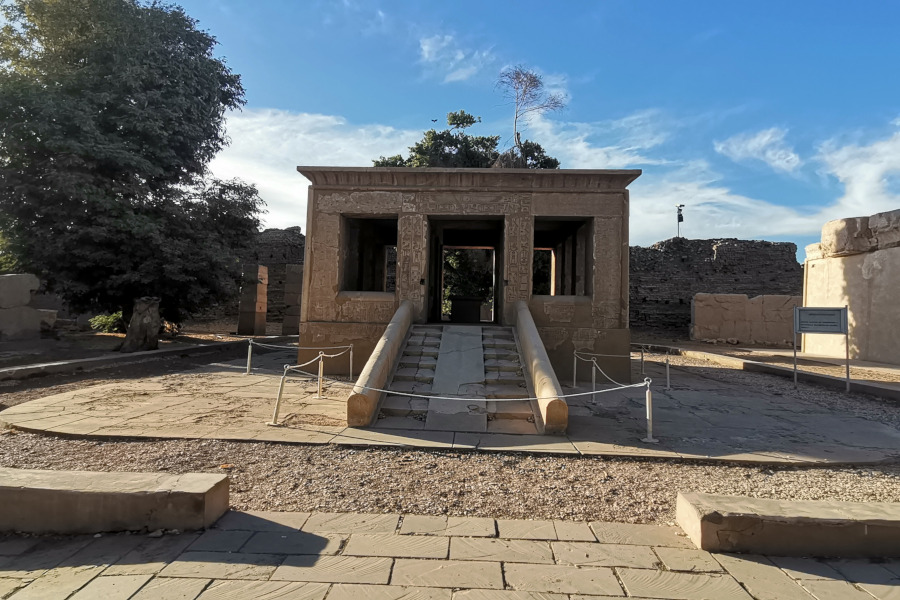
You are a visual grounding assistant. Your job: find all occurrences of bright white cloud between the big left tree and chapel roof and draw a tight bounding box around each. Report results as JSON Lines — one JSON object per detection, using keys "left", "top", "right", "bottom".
{"left": 210, "top": 109, "right": 422, "bottom": 229}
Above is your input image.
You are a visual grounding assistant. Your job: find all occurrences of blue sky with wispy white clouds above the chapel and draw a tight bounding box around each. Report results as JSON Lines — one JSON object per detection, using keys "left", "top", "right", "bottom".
{"left": 181, "top": 0, "right": 900, "bottom": 259}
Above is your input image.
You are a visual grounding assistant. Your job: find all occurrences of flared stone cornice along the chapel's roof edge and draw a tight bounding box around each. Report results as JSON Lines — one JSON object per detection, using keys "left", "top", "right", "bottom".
{"left": 297, "top": 166, "right": 641, "bottom": 192}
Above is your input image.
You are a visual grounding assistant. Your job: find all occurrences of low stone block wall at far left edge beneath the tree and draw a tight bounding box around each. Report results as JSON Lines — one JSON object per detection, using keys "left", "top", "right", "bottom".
{"left": 0, "top": 273, "right": 56, "bottom": 341}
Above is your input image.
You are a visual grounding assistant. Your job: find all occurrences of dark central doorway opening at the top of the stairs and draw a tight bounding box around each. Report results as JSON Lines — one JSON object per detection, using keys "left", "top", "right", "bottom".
{"left": 428, "top": 216, "right": 503, "bottom": 323}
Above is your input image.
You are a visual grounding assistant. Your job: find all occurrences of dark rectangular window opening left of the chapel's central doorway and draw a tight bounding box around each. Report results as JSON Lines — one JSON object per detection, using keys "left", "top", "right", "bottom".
{"left": 341, "top": 217, "right": 398, "bottom": 292}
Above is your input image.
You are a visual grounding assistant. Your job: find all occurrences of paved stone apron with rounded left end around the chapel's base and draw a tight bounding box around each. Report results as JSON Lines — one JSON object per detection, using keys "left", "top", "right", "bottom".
{"left": 0, "top": 353, "right": 900, "bottom": 464}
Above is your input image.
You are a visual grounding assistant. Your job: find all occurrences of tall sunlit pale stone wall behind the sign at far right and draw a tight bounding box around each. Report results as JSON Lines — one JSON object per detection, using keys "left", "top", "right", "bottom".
{"left": 803, "top": 210, "right": 900, "bottom": 364}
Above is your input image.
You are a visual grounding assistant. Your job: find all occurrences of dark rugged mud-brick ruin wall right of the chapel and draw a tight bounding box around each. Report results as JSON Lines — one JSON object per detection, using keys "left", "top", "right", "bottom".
{"left": 629, "top": 238, "right": 803, "bottom": 334}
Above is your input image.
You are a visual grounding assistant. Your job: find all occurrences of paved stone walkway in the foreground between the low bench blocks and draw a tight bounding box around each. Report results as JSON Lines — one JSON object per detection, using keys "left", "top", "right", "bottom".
{"left": 0, "top": 512, "right": 900, "bottom": 600}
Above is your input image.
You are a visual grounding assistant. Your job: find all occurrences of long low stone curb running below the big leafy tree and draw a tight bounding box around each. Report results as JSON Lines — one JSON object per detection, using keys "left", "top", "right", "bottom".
{"left": 0, "top": 336, "right": 300, "bottom": 381}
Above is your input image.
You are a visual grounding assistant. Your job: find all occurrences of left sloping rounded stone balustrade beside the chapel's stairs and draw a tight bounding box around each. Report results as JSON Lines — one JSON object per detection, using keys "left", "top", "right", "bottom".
{"left": 347, "top": 300, "right": 414, "bottom": 427}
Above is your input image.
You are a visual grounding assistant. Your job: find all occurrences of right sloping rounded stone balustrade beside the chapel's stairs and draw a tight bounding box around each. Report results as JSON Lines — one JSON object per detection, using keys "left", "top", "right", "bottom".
{"left": 516, "top": 300, "right": 569, "bottom": 434}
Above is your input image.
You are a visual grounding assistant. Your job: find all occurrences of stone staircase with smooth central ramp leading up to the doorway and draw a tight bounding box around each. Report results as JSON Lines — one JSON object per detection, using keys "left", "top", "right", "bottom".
{"left": 375, "top": 325, "right": 536, "bottom": 433}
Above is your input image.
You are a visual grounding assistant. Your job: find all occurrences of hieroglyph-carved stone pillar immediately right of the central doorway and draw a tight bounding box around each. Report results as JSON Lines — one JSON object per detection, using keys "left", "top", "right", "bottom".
{"left": 503, "top": 195, "right": 534, "bottom": 303}
